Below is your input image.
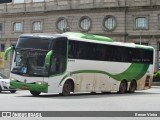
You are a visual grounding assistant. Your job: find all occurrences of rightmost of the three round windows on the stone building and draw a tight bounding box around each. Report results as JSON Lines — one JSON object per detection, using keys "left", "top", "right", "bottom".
{"left": 103, "top": 15, "right": 116, "bottom": 31}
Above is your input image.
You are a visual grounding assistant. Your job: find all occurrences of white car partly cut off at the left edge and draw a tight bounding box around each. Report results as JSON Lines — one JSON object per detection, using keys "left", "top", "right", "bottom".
{"left": 0, "top": 73, "right": 16, "bottom": 93}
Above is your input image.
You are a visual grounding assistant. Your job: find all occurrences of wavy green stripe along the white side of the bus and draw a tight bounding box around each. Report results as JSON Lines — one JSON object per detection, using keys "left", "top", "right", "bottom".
{"left": 59, "top": 64, "right": 149, "bottom": 84}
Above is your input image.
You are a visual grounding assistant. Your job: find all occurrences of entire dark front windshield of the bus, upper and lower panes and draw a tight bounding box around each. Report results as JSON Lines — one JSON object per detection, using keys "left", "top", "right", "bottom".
{"left": 11, "top": 37, "right": 51, "bottom": 76}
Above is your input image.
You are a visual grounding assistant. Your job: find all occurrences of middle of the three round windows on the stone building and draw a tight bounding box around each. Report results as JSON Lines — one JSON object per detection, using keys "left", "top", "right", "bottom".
{"left": 79, "top": 16, "right": 92, "bottom": 31}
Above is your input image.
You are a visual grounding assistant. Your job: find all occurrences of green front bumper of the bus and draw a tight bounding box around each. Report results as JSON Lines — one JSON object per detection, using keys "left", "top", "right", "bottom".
{"left": 10, "top": 80, "right": 48, "bottom": 93}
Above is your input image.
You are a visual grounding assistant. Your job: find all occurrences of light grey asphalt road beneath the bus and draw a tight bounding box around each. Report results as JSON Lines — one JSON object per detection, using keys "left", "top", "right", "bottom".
{"left": 0, "top": 86, "right": 160, "bottom": 120}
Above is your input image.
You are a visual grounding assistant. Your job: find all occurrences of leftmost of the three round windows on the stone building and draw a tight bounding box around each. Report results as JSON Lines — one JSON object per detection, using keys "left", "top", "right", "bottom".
{"left": 56, "top": 18, "right": 67, "bottom": 32}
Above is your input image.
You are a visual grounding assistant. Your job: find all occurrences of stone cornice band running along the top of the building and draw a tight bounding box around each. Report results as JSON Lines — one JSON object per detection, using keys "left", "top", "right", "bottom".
{"left": 0, "top": 0, "right": 160, "bottom": 15}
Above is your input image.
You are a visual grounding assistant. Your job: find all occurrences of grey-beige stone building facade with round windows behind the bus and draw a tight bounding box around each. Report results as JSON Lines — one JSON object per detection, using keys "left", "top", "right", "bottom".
{"left": 0, "top": 0, "right": 160, "bottom": 74}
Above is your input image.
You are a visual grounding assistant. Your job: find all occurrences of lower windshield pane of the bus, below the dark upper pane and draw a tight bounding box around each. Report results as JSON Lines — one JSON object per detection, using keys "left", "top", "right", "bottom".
{"left": 11, "top": 49, "right": 48, "bottom": 76}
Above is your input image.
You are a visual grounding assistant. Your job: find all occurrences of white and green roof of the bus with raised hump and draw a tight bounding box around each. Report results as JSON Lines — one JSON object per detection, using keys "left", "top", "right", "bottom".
{"left": 20, "top": 32, "right": 154, "bottom": 50}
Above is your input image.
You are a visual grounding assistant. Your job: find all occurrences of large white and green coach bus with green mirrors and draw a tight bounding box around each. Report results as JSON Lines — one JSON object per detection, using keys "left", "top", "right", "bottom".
{"left": 5, "top": 32, "right": 155, "bottom": 96}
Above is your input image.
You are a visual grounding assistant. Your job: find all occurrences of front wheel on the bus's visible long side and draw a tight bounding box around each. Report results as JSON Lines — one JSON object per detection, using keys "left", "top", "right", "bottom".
{"left": 62, "top": 80, "right": 71, "bottom": 96}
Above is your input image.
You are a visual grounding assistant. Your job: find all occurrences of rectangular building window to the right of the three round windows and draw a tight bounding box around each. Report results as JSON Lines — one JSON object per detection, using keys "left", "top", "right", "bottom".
{"left": 135, "top": 17, "right": 148, "bottom": 29}
